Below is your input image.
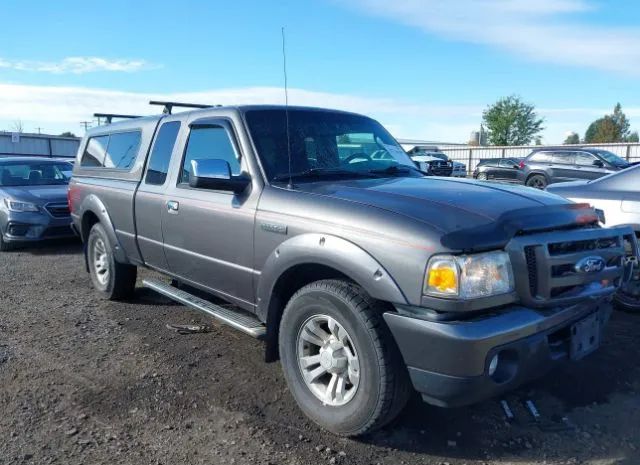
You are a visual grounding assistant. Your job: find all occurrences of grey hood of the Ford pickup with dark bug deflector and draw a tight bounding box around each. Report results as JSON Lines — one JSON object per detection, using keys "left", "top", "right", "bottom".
{"left": 296, "top": 177, "right": 597, "bottom": 249}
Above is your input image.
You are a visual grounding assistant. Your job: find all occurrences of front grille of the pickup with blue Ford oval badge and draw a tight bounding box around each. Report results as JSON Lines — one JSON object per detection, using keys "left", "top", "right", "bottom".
{"left": 507, "top": 227, "right": 628, "bottom": 307}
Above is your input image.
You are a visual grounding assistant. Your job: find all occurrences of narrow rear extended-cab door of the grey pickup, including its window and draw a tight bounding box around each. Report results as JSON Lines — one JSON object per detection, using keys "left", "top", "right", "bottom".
{"left": 135, "top": 120, "right": 186, "bottom": 271}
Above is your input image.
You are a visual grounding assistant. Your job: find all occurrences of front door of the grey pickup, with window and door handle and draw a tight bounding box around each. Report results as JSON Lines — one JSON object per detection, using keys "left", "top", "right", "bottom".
{"left": 162, "top": 117, "right": 260, "bottom": 307}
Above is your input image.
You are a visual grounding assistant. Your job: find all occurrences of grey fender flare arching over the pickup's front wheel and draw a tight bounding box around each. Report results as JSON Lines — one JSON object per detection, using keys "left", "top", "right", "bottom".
{"left": 257, "top": 233, "right": 407, "bottom": 321}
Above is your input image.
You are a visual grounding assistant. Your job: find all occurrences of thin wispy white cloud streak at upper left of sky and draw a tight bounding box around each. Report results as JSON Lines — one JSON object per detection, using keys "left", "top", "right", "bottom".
{"left": 0, "top": 57, "right": 158, "bottom": 74}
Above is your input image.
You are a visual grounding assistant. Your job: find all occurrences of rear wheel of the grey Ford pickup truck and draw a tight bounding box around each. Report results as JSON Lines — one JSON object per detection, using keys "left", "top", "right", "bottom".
{"left": 86, "top": 223, "right": 138, "bottom": 300}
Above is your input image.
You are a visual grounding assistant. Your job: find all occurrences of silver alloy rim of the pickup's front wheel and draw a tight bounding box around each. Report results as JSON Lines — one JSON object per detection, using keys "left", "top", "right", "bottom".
{"left": 297, "top": 315, "right": 360, "bottom": 407}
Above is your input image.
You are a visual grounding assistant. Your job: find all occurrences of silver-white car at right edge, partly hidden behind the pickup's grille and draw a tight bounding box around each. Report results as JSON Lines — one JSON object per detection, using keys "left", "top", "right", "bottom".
{"left": 547, "top": 165, "right": 640, "bottom": 311}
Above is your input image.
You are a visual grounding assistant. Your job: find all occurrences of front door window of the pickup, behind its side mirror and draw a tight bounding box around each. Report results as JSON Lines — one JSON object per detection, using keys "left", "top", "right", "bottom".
{"left": 179, "top": 126, "right": 240, "bottom": 183}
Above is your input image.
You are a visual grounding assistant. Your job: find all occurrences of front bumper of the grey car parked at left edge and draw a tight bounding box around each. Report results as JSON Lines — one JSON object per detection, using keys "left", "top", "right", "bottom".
{"left": 0, "top": 208, "right": 74, "bottom": 243}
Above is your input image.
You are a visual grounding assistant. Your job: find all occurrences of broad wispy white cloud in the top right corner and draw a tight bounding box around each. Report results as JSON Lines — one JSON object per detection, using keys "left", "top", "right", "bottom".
{"left": 343, "top": 0, "right": 640, "bottom": 76}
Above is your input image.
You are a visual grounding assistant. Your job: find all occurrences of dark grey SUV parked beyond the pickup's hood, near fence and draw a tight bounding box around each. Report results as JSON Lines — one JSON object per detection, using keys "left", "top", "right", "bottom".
{"left": 521, "top": 147, "right": 629, "bottom": 189}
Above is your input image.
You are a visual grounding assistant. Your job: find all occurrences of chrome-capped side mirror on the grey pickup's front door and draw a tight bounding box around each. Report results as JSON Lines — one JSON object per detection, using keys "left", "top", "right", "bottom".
{"left": 189, "top": 158, "right": 251, "bottom": 194}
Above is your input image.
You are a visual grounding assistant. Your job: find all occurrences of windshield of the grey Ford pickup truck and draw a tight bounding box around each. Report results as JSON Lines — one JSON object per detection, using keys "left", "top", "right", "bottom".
{"left": 246, "top": 109, "right": 422, "bottom": 182}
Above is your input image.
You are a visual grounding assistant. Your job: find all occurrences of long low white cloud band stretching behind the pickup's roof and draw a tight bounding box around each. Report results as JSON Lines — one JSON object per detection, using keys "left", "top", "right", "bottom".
{"left": 0, "top": 83, "right": 640, "bottom": 143}
